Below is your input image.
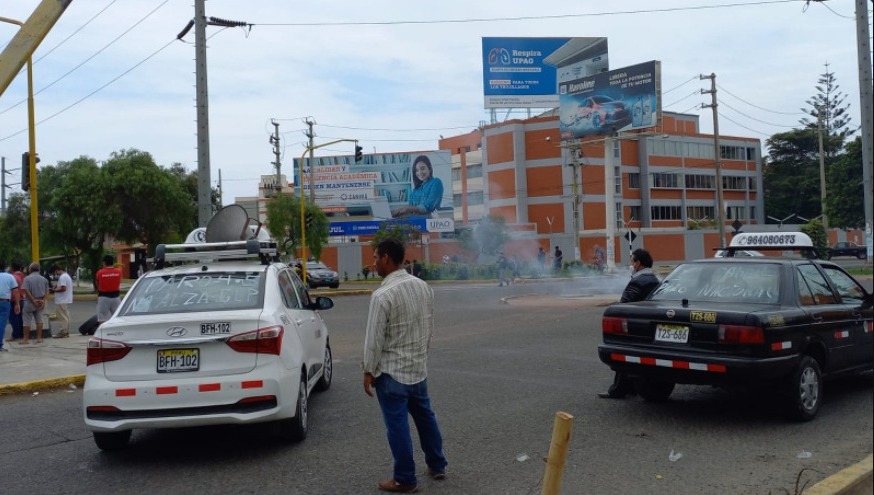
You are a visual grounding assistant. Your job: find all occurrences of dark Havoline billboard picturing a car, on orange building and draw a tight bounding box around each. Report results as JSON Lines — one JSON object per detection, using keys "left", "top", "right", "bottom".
{"left": 559, "top": 61, "right": 662, "bottom": 139}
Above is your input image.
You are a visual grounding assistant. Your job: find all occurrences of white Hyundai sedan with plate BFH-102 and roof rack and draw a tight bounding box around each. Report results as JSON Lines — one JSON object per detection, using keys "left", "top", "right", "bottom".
{"left": 83, "top": 240, "right": 333, "bottom": 450}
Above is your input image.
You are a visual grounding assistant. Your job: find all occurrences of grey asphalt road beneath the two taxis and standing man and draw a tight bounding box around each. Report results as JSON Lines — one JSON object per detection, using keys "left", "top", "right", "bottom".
{"left": 0, "top": 282, "right": 874, "bottom": 495}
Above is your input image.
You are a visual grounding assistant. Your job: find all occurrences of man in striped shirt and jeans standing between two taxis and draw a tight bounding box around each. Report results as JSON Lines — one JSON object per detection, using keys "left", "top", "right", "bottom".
{"left": 363, "top": 239, "right": 446, "bottom": 493}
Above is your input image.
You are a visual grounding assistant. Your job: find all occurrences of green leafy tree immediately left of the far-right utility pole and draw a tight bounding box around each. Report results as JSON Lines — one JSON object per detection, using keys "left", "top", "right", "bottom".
{"left": 826, "top": 137, "right": 865, "bottom": 228}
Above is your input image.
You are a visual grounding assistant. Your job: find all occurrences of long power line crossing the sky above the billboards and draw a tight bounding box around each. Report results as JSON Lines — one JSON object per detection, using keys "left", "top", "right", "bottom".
{"left": 250, "top": 0, "right": 804, "bottom": 27}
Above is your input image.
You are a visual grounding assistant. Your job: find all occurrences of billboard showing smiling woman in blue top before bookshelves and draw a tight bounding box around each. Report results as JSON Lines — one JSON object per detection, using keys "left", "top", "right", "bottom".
{"left": 294, "top": 151, "right": 453, "bottom": 235}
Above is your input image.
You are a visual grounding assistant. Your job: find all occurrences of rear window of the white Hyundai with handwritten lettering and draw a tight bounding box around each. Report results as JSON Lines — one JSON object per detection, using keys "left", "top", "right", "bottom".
{"left": 121, "top": 271, "right": 265, "bottom": 316}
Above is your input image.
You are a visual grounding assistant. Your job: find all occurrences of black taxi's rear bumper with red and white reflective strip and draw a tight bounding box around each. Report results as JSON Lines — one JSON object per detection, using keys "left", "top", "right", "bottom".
{"left": 598, "top": 344, "right": 799, "bottom": 385}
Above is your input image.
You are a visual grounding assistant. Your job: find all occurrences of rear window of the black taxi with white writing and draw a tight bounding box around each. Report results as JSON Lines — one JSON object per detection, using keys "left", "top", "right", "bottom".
{"left": 650, "top": 262, "right": 780, "bottom": 304}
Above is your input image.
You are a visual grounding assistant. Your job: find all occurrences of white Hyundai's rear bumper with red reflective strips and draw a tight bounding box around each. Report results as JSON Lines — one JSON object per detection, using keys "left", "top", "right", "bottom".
{"left": 83, "top": 369, "right": 300, "bottom": 432}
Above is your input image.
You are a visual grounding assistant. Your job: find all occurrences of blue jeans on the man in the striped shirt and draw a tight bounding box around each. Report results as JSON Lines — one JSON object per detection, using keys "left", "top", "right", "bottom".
{"left": 376, "top": 373, "right": 446, "bottom": 485}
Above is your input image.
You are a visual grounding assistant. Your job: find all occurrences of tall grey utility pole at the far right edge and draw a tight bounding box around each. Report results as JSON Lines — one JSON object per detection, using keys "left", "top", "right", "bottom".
{"left": 856, "top": 0, "right": 874, "bottom": 262}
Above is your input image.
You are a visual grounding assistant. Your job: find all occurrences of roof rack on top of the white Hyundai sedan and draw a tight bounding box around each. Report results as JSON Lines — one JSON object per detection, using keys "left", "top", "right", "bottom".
{"left": 155, "top": 239, "right": 276, "bottom": 269}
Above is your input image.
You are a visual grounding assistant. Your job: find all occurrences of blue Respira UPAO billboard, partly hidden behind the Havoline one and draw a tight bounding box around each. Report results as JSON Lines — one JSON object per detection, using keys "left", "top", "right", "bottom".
{"left": 482, "top": 37, "right": 609, "bottom": 108}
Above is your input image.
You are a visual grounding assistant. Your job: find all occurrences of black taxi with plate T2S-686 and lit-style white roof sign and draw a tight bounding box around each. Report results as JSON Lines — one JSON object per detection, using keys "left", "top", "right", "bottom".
{"left": 598, "top": 232, "right": 874, "bottom": 421}
